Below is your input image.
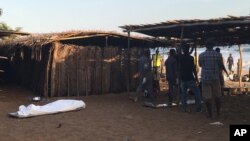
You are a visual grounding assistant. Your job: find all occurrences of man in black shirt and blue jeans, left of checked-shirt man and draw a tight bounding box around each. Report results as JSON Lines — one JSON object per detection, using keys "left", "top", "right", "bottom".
{"left": 180, "top": 44, "right": 201, "bottom": 112}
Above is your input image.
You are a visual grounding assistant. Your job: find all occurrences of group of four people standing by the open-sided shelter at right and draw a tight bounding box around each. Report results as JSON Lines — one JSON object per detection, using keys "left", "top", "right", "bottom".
{"left": 134, "top": 39, "right": 231, "bottom": 118}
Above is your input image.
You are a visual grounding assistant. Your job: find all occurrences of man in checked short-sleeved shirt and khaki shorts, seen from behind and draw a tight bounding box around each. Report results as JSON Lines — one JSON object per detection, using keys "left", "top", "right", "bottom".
{"left": 199, "top": 39, "right": 222, "bottom": 118}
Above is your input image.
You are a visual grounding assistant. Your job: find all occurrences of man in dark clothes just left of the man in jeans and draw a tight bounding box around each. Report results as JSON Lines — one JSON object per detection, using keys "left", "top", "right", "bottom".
{"left": 165, "top": 49, "right": 177, "bottom": 105}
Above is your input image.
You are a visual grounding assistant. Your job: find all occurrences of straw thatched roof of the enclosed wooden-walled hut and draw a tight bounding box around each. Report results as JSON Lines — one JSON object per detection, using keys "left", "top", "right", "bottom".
{"left": 2, "top": 31, "right": 164, "bottom": 48}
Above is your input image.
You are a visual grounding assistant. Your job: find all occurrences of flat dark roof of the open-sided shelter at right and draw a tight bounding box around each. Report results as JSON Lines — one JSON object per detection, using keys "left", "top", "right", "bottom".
{"left": 121, "top": 16, "right": 250, "bottom": 45}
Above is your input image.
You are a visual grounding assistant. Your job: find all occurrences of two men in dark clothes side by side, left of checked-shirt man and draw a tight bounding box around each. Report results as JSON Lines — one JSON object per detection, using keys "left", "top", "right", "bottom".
{"left": 165, "top": 44, "right": 201, "bottom": 112}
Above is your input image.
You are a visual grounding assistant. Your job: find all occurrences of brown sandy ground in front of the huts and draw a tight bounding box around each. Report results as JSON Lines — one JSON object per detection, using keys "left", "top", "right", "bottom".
{"left": 0, "top": 82, "right": 250, "bottom": 141}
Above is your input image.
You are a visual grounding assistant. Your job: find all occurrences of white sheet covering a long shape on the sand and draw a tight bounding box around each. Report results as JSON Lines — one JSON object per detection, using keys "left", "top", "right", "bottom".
{"left": 9, "top": 100, "right": 86, "bottom": 118}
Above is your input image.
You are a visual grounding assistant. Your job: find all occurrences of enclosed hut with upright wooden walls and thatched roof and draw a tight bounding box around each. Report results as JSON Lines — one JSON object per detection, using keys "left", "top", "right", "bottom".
{"left": 0, "top": 31, "right": 160, "bottom": 97}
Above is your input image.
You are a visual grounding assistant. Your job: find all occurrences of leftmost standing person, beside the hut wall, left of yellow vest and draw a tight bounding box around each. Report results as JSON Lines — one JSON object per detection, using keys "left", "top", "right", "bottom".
{"left": 134, "top": 50, "right": 153, "bottom": 102}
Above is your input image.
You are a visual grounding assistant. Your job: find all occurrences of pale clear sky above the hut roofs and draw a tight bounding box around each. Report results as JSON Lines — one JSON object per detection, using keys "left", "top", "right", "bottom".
{"left": 0, "top": 0, "right": 250, "bottom": 33}
